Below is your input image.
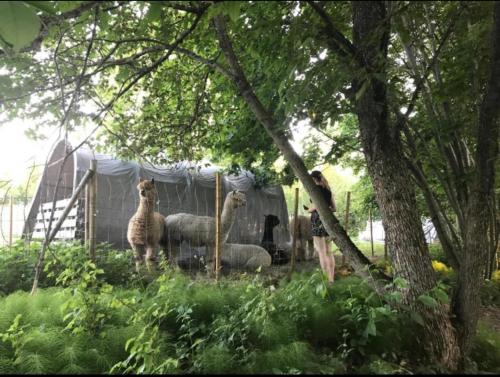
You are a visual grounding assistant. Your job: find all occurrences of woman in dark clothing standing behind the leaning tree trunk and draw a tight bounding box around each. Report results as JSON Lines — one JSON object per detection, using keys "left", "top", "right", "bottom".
{"left": 307, "top": 170, "right": 336, "bottom": 283}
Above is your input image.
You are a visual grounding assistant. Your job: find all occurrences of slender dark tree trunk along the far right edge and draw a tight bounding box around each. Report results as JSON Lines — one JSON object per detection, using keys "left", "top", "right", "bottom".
{"left": 452, "top": 1, "right": 500, "bottom": 366}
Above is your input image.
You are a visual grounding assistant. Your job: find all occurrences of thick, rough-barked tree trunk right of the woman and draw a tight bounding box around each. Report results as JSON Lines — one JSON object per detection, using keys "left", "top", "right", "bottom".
{"left": 352, "top": 1, "right": 459, "bottom": 370}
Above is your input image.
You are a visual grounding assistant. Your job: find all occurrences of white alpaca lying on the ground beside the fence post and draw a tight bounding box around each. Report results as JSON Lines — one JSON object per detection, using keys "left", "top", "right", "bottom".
{"left": 221, "top": 243, "right": 272, "bottom": 270}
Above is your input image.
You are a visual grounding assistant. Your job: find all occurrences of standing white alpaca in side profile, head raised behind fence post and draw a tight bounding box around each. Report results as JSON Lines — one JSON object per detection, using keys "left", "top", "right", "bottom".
{"left": 165, "top": 190, "right": 246, "bottom": 268}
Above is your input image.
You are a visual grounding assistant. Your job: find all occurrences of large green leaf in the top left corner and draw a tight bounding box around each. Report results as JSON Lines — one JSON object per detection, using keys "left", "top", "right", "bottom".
{"left": 0, "top": 1, "right": 40, "bottom": 51}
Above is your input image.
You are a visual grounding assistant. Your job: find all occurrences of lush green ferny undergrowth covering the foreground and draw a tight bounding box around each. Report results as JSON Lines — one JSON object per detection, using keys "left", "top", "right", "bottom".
{"left": 0, "top": 241, "right": 500, "bottom": 374}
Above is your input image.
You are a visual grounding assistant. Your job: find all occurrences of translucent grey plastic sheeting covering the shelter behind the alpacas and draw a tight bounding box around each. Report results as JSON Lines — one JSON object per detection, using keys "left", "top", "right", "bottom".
{"left": 24, "top": 141, "right": 290, "bottom": 249}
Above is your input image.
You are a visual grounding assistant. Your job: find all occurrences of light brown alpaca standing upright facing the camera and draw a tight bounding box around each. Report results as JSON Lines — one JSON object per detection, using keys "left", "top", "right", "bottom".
{"left": 127, "top": 178, "right": 167, "bottom": 273}
